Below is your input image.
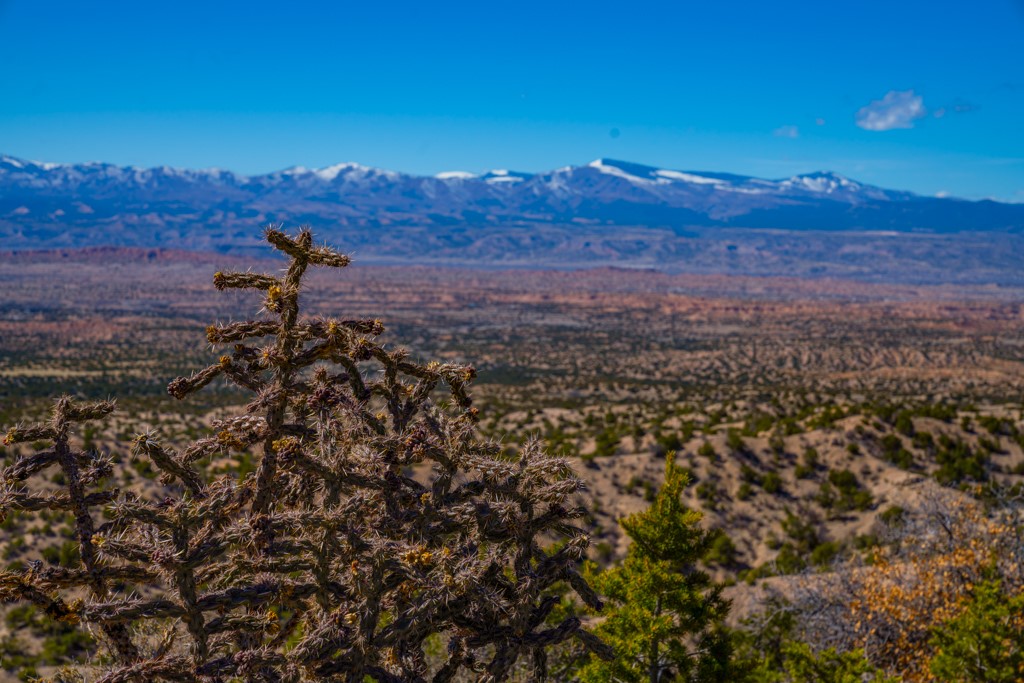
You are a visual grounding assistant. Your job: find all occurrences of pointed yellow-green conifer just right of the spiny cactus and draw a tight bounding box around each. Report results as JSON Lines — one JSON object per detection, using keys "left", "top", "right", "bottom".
{"left": 579, "top": 456, "right": 731, "bottom": 683}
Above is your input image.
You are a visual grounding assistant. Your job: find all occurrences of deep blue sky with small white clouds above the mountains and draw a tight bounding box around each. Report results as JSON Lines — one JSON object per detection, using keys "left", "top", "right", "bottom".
{"left": 0, "top": 0, "right": 1024, "bottom": 202}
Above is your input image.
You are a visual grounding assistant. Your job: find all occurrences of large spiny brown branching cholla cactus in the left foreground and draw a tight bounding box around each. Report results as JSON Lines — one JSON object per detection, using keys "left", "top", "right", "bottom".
{"left": 2, "top": 229, "right": 610, "bottom": 683}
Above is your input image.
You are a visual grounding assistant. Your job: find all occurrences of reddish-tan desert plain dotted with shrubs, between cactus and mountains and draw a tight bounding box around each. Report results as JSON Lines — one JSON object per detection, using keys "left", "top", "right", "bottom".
{"left": 0, "top": 249, "right": 1024, "bottom": 574}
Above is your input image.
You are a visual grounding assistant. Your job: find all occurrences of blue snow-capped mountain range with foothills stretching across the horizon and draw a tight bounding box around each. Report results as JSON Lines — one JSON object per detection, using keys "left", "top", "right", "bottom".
{"left": 0, "top": 156, "right": 1024, "bottom": 281}
